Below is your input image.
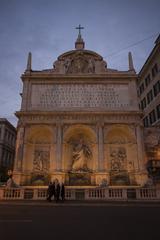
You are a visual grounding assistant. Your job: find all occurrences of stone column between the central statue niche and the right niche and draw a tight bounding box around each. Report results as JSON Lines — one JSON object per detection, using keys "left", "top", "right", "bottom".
{"left": 98, "top": 124, "right": 104, "bottom": 171}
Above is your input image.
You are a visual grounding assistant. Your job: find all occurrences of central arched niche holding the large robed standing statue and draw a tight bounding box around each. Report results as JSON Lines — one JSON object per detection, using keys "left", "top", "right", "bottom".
{"left": 62, "top": 124, "right": 97, "bottom": 185}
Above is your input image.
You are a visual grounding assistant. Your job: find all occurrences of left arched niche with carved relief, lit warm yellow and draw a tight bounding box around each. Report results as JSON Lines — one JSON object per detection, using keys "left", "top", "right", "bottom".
{"left": 23, "top": 125, "right": 55, "bottom": 176}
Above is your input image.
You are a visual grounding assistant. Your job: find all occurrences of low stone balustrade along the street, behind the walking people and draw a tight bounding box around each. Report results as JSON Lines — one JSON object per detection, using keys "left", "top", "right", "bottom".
{"left": 0, "top": 187, "right": 160, "bottom": 201}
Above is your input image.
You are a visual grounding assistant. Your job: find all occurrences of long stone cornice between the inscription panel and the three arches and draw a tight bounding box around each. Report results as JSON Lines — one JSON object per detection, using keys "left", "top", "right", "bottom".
{"left": 16, "top": 112, "right": 142, "bottom": 126}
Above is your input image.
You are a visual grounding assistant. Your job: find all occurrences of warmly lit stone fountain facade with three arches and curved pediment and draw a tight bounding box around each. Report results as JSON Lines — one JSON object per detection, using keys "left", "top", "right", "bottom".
{"left": 14, "top": 37, "right": 147, "bottom": 185}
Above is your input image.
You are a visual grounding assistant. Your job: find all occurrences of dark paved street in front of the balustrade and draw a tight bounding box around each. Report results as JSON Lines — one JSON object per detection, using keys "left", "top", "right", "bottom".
{"left": 0, "top": 203, "right": 160, "bottom": 240}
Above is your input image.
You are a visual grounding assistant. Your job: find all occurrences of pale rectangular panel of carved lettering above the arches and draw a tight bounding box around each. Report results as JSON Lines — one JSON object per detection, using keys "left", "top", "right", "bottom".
{"left": 31, "top": 84, "right": 130, "bottom": 110}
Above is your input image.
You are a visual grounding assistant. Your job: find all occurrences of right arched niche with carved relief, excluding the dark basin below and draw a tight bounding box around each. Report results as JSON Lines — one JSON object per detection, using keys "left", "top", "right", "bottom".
{"left": 104, "top": 125, "right": 138, "bottom": 175}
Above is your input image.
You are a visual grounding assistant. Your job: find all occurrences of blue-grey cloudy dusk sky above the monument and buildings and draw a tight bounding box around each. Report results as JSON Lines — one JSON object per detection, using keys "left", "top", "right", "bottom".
{"left": 0, "top": 0, "right": 160, "bottom": 126}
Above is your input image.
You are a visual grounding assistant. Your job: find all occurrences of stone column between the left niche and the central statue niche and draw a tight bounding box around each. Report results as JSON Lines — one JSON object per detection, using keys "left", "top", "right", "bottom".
{"left": 56, "top": 123, "right": 62, "bottom": 171}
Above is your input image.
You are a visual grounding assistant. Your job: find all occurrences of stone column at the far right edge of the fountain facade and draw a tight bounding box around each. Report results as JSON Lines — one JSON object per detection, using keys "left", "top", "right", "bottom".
{"left": 136, "top": 125, "right": 144, "bottom": 170}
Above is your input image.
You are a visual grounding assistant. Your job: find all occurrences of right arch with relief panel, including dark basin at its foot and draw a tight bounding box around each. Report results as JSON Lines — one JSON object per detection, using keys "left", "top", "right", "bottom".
{"left": 104, "top": 124, "right": 138, "bottom": 185}
